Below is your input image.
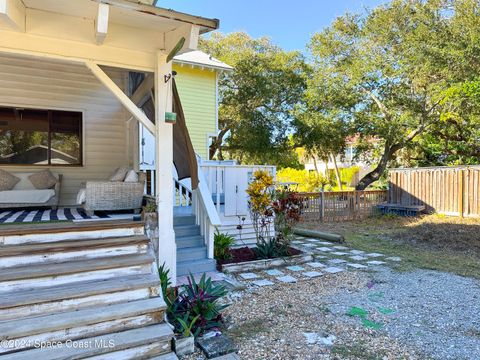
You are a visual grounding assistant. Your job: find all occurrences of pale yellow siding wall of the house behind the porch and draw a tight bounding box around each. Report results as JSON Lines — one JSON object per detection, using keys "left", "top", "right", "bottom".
{"left": 173, "top": 64, "right": 216, "bottom": 159}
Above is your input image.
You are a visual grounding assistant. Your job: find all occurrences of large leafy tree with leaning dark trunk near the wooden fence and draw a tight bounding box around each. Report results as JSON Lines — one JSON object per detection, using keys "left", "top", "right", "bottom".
{"left": 306, "top": 0, "right": 480, "bottom": 190}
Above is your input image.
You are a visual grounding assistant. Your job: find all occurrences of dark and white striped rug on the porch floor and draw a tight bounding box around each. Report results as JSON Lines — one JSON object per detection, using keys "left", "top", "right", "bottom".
{"left": 0, "top": 208, "right": 109, "bottom": 224}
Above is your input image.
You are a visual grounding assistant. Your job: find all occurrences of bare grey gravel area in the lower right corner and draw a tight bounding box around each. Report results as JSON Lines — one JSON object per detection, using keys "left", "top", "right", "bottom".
{"left": 326, "top": 268, "right": 480, "bottom": 360}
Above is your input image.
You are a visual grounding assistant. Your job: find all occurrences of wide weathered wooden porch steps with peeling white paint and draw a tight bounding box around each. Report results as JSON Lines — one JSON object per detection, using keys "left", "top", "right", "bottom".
{"left": 0, "top": 221, "right": 178, "bottom": 360}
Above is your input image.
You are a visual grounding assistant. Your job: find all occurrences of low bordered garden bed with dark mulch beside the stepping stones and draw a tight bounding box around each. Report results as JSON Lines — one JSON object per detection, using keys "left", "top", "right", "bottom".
{"left": 217, "top": 247, "right": 312, "bottom": 273}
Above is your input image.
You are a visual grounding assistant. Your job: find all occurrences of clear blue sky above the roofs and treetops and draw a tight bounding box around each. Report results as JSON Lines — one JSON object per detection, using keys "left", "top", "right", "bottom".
{"left": 157, "top": 0, "right": 385, "bottom": 51}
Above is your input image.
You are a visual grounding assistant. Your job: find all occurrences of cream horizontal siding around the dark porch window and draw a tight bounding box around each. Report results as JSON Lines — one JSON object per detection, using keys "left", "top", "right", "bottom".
{"left": 0, "top": 55, "right": 129, "bottom": 205}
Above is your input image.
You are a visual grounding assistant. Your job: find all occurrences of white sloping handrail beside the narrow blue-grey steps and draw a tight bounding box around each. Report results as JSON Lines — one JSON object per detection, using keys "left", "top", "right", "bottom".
{"left": 192, "top": 166, "right": 222, "bottom": 259}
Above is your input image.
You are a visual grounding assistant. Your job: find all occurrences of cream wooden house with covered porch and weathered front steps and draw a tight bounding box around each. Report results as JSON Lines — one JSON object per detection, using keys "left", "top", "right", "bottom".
{"left": 0, "top": 0, "right": 219, "bottom": 359}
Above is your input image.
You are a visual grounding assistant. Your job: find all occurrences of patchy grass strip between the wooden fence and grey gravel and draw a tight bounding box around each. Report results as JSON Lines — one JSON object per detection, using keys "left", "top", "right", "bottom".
{"left": 306, "top": 214, "right": 480, "bottom": 279}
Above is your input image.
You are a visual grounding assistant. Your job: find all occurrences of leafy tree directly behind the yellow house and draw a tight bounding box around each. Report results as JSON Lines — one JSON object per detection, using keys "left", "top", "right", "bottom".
{"left": 200, "top": 32, "right": 307, "bottom": 166}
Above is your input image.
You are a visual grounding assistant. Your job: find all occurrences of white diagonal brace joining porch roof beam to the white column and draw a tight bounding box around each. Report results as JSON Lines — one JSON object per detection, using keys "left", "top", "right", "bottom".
{"left": 85, "top": 61, "right": 155, "bottom": 135}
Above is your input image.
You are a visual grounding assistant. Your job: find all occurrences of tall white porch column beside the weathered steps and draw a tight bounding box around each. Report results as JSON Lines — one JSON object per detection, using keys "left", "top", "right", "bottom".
{"left": 155, "top": 52, "right": 177, "bottom": 285}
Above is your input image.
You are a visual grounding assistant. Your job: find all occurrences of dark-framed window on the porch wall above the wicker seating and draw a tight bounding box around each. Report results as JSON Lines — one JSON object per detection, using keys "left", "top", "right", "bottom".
{"left": 0, "top": 107, "right": 82, "bottom": 166}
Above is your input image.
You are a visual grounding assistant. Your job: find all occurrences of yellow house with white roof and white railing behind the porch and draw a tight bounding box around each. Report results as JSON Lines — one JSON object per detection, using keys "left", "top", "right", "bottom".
{"left": 139, "top": 50, "right": 275, "bottom": 245}
